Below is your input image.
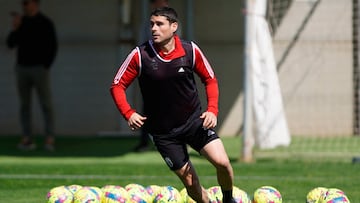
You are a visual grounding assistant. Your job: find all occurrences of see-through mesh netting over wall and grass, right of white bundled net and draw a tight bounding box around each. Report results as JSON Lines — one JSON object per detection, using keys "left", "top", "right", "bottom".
{"left": 244, "top": 0, "right": 360, "bottom": 161}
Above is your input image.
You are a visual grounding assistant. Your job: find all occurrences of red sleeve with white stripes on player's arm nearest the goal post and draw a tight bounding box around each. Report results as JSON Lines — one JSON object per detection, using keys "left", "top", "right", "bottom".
{"left": 192, "top": 43, "right": 219, "bottom": 116}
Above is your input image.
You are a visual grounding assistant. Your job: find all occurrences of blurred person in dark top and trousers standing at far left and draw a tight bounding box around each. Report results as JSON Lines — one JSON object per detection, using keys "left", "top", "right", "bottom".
{"left": 7, "top": 0, "right": 58, "bottom": 151}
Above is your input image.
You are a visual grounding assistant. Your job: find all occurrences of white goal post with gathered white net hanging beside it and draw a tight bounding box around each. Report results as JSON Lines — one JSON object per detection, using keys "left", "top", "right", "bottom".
{"left": 241, "top": 0, "right": 290, "bottom": 162}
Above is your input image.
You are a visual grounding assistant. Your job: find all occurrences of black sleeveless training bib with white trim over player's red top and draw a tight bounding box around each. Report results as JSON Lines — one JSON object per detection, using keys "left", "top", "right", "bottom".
{"left": 139, "top": 41, "right": 201, "bottom": 133}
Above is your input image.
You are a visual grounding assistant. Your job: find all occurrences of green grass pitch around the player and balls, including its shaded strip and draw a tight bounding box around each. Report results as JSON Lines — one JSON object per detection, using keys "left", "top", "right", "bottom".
{"left": 0, "top": 136, "right": 360, "bottom": 203}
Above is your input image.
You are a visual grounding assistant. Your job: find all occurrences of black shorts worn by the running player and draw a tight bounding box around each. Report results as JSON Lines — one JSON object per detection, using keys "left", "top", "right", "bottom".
{"left": 151, "top": 119, "right": 219, "bottom": 170}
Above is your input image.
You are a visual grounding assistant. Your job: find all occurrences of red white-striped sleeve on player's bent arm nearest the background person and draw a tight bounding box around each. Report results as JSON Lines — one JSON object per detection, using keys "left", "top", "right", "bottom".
{"left": 110, "top": 48, "right": 140, "bottom": 120}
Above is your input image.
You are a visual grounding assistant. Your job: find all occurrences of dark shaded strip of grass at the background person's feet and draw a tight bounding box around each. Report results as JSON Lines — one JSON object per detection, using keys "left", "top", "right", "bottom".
{"left": 0, "top": 136, "right": 153, "bottom": 157}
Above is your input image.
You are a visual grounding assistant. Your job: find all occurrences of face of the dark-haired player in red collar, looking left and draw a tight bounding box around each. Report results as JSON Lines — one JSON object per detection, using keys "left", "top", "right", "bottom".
{"left": 150, "top": 16, "right": 178, "bottom": 44}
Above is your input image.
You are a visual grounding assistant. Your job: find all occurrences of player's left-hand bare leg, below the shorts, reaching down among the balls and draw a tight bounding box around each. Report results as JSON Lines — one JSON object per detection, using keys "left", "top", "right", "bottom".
{"left": 175, "top": 161, "right": 209, "bottom": 203}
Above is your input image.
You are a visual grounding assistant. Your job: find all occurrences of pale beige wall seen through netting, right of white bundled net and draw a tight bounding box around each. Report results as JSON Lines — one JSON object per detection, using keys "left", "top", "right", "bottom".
{"left": 268, "top": 0, "right": 352, "bottom": 137}
